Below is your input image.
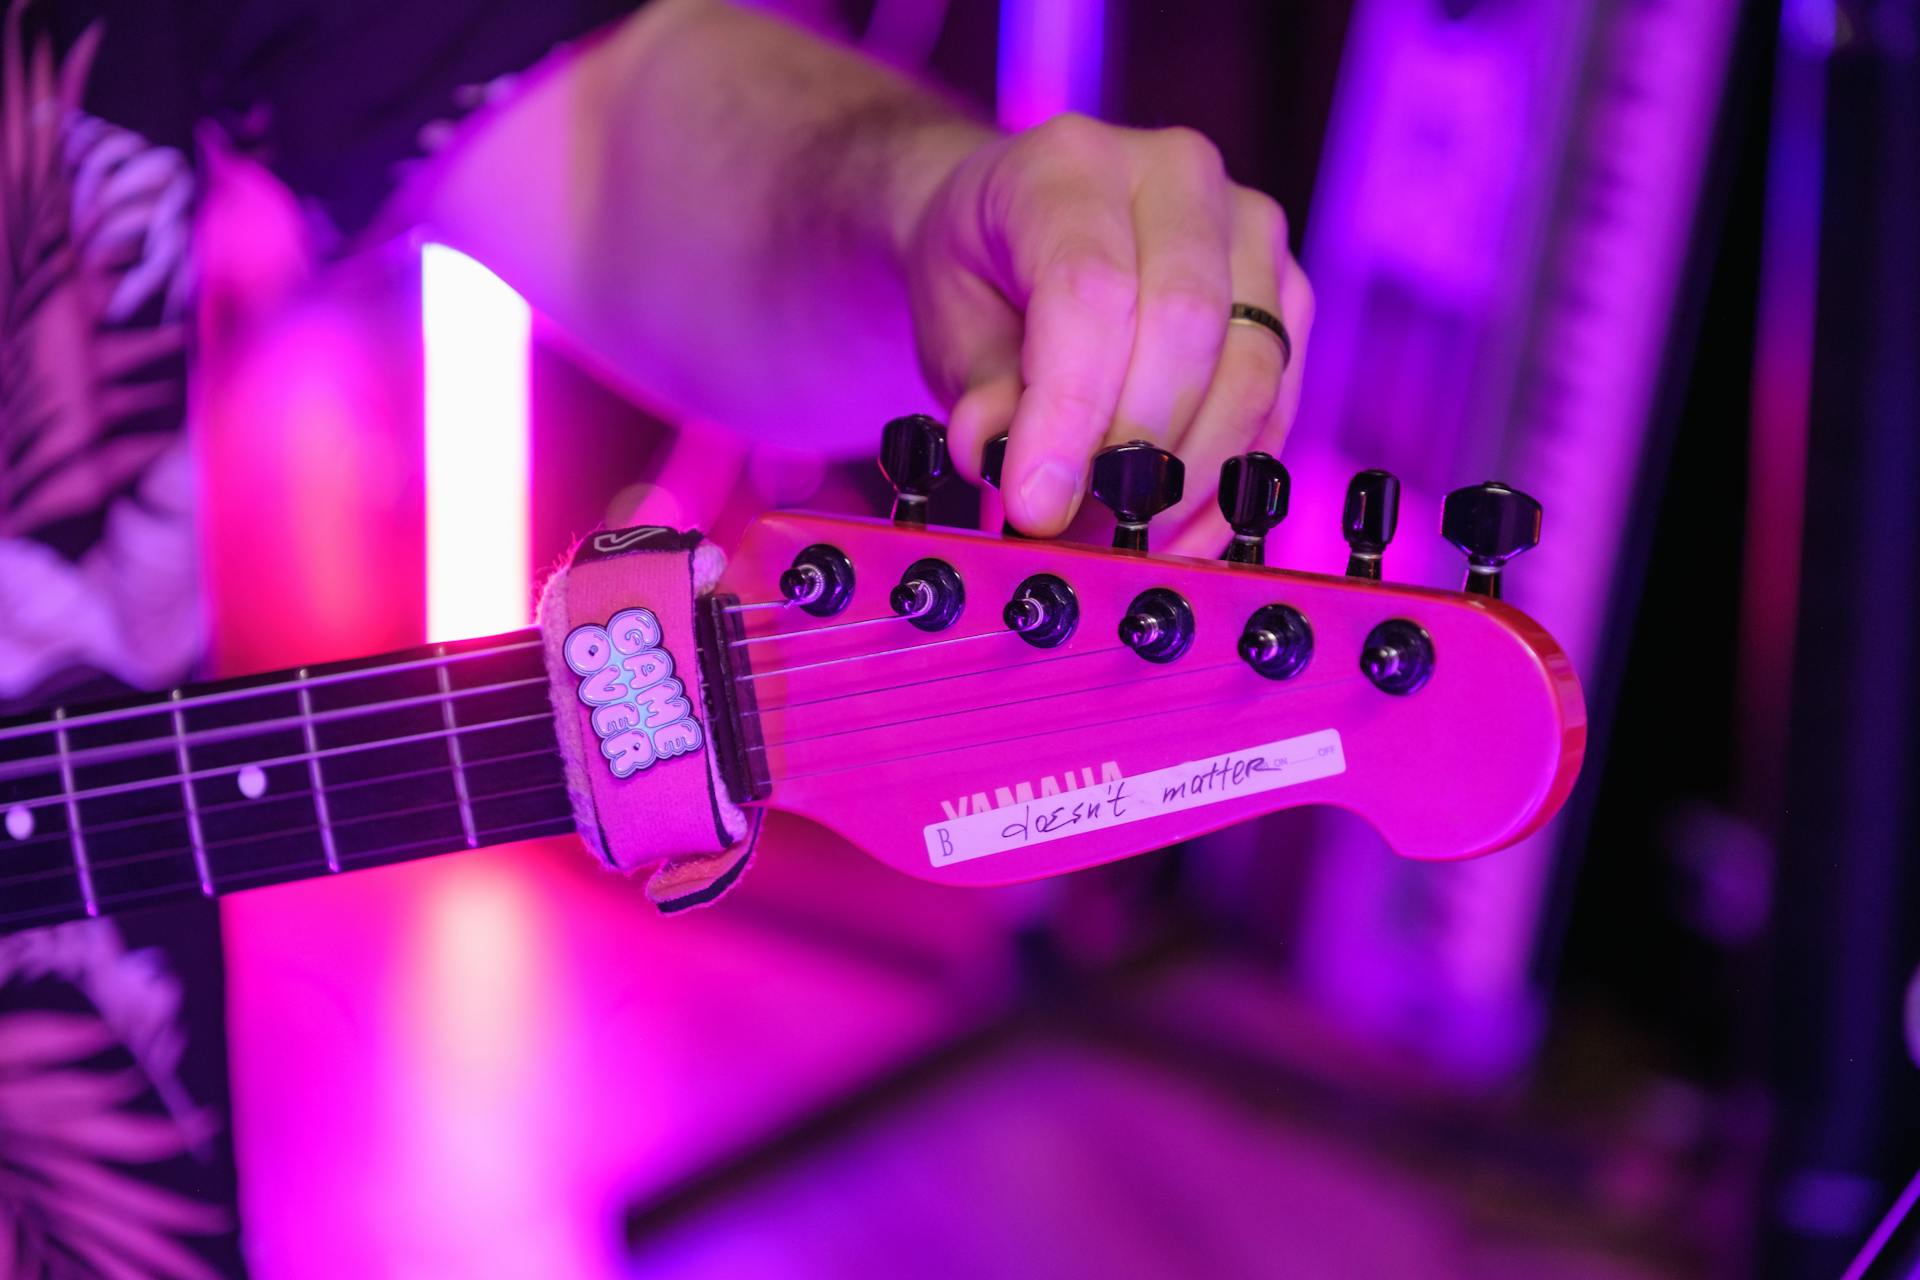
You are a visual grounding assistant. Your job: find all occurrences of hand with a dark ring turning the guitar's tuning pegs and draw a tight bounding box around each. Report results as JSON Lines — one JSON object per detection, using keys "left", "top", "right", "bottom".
{"left": 908, "top": 115, "right": 1313, "bottom": 555}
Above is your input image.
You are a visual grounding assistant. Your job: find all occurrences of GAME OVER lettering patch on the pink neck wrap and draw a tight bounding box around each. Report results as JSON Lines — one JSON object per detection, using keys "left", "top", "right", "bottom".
{"left": 561, "top": 608, "right": 707, "bottom": 777}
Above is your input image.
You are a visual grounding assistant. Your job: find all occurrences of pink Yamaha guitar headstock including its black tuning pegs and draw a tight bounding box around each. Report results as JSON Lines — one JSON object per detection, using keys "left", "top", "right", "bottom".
{"left": 708, "top": 426, "right": 1586, "bottom": 885}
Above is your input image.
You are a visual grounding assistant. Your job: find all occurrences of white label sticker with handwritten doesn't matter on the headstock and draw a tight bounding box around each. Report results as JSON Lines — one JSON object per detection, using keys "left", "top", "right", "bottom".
{"left": 925, "top": 729, "right": 1346, "bottom": 867}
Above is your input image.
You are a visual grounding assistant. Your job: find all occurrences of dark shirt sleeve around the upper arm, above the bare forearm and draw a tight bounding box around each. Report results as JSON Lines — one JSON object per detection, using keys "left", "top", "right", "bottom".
{"left": 202, "top": 0, "right": 639, "bottom": 238}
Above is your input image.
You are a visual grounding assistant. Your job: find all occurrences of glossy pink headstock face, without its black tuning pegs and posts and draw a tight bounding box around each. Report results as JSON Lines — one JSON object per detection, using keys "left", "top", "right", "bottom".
{"left": 720, "top": 512, "right": 1586, "bottom": 885}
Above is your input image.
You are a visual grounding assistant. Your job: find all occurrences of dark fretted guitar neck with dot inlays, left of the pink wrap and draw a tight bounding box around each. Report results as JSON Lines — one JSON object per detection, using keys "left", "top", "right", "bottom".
{"left": 0, "top": 629, "right": 574, "bottom": 929}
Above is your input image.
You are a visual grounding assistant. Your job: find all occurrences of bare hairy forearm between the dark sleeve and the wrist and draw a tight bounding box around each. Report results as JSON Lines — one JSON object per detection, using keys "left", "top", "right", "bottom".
{"left": 426, "top": 0, "right": 991, "bottom": 447}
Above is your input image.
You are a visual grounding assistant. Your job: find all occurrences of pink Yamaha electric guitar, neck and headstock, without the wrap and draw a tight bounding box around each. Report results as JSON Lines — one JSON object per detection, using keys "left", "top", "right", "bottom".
{"left": 0, "top": 429, "right": 1586, "bottom": 929}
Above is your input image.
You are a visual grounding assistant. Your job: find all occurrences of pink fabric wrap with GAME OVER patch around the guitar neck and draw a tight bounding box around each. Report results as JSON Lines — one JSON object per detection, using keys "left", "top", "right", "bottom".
{"left": 540, "top": 526, "right": 760, "bottom": 912}
